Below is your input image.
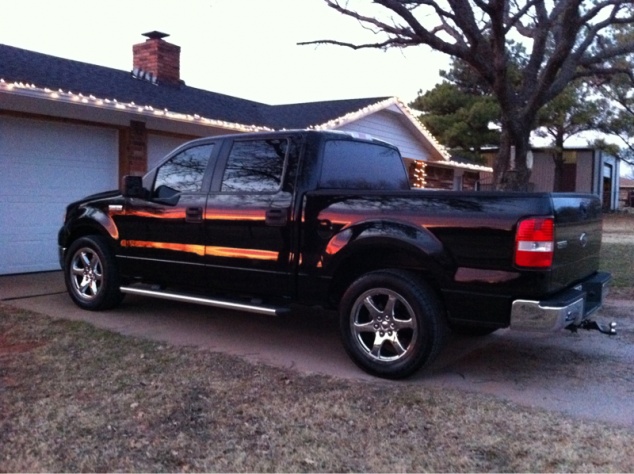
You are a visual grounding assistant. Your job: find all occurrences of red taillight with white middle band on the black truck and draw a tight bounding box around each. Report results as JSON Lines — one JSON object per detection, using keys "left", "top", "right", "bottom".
{"left": 515, "top": 217, "right": 555, "bottom": 268}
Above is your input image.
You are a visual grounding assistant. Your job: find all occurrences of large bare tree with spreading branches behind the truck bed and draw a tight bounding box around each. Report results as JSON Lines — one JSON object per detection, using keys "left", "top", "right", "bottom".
{"left": 300, "top": 0, "right": 634, "bottom": 190}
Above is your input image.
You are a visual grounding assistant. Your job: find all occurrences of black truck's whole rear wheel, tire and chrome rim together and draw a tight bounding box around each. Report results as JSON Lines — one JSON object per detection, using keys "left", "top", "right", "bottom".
{"left": 340, "top": 270, "right": 447, "bottom": 379}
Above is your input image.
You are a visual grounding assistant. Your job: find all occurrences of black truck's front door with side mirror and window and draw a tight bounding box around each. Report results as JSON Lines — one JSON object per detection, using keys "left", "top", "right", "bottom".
{"left": 119, "top": 139, "right": 215, "bottom": 285}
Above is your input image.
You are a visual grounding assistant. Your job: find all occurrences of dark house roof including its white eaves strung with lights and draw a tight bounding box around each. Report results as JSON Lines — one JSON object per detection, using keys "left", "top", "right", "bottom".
{"left": 0, "top": 44, "right": 490, "bottom": 171}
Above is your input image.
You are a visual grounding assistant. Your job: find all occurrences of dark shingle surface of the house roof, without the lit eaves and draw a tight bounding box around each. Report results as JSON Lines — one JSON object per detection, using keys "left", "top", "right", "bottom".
{"left": 0, "top": 44, "right": 387, "bottom": 129}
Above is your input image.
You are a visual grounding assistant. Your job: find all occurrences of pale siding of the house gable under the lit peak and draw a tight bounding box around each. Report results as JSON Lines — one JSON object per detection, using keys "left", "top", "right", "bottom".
{"left": 338, "top": 110, "right": 430, "bottom": 161}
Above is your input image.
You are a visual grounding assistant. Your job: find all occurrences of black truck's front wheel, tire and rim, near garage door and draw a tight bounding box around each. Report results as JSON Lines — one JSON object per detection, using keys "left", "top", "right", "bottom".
{"left": 64, "top": 235, "right": 123, "bottom": 311}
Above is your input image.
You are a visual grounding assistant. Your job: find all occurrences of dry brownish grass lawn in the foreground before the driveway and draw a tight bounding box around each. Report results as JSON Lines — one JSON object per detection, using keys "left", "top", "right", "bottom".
{"left": 0, "top": 306, "right": 634, "bottom": 472}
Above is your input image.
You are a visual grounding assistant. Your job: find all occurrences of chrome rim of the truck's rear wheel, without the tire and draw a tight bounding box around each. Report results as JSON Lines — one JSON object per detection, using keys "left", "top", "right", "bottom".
{"left": 350, "top": 288, "right": 418, "bottom": 362}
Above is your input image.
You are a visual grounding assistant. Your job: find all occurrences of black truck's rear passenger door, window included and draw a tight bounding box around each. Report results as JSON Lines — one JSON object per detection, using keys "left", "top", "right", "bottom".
{"left": 205, "top": 135, "right": 299, "bottom": 296}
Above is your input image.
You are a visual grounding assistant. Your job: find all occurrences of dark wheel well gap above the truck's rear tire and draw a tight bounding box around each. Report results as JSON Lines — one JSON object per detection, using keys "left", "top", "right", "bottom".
{"left": 329, "top": 247, "right": 442, "bottom": 307}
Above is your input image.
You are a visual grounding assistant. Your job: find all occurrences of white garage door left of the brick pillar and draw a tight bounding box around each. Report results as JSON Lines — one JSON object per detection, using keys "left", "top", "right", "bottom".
{"left": 0, "top": 117, "right": 118, "bottom": 275}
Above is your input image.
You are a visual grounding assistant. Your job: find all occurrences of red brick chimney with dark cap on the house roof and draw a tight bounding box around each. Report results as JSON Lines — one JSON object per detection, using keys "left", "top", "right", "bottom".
{"left": 132, "top": 31, "right": 181, "bottom": 85}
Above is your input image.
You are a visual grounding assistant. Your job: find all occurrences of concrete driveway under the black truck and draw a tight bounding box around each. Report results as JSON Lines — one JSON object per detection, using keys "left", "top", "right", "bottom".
{"left": 0, "top": 272, "right": 634, "bottom": 426}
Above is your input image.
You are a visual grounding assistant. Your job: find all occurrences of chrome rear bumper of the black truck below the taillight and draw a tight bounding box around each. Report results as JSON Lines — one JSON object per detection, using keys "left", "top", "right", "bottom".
{"left": 511, "top": 272, "right": 612, "bottom": 331}
